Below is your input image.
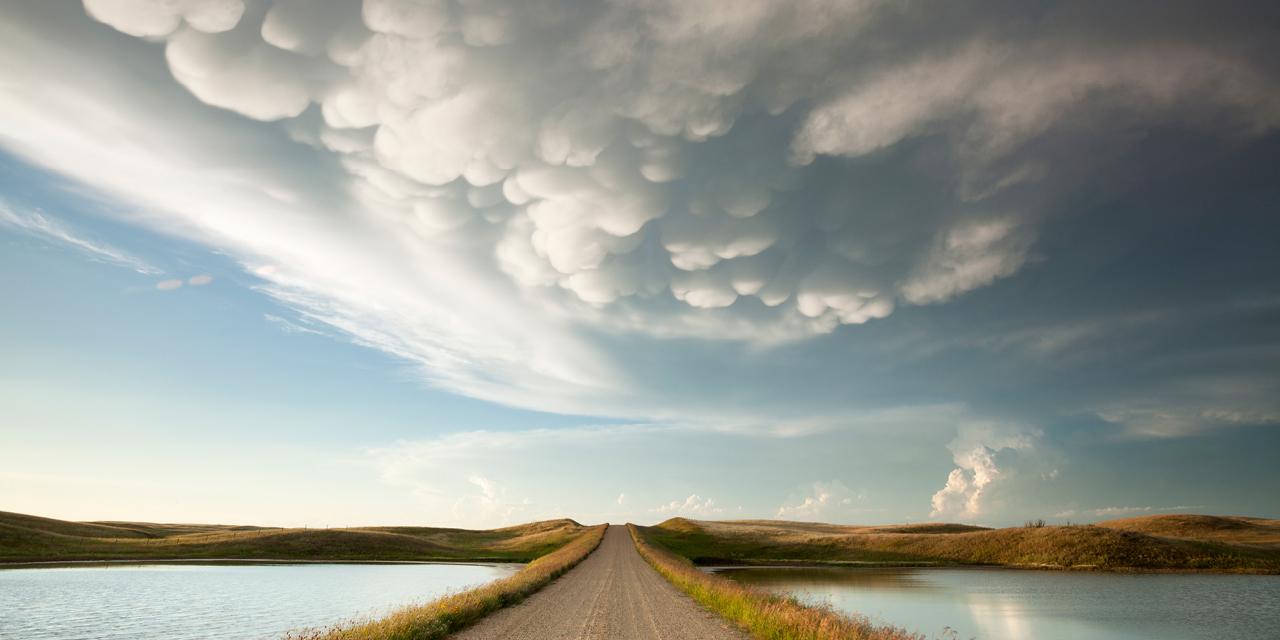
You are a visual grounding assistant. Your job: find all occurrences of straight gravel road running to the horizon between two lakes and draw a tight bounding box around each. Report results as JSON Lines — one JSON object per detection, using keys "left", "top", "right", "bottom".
{"left": 452, "top": 526, "right": 748, "bottom": 640}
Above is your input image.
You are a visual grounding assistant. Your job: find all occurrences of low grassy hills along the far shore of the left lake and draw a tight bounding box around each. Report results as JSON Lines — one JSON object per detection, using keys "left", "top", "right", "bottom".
{"left": 0, "top": 512, "right": 586, "bottom": 563}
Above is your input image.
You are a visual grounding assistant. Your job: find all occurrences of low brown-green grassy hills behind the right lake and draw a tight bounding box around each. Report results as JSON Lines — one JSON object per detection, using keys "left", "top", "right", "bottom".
{"left": 644, "top": 516, "right": 1280, "bottom": 573}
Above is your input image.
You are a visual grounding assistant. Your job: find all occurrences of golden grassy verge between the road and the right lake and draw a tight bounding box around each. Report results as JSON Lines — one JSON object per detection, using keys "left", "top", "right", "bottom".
{"left": 627, "top": 525, "right": 923, "bottom": 640}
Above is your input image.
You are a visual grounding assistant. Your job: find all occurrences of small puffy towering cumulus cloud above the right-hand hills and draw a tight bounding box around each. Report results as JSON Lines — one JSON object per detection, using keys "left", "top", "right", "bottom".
{"left": 929, "top": 425, "right": 1038, "bottom": 518}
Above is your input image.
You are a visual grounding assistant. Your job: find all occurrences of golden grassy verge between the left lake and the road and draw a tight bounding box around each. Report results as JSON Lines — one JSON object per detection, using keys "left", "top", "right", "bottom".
{"left": 287, "top": 525, "right": 608, "bottom": 640}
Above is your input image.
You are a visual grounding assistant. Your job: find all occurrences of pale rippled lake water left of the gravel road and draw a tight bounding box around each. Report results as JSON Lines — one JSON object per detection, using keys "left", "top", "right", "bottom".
{"left": 0, "top": 564, "right": 520, "bottom": 640}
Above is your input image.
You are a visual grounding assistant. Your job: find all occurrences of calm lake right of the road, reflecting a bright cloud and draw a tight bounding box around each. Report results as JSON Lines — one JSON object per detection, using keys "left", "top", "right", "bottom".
{"left": 712, "top": 568, "right": 1280, "bottom": 640}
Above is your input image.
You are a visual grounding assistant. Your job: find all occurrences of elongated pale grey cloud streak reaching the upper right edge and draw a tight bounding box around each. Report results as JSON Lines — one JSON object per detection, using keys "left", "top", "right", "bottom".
{"left": 794, "top": 42, "right": 1280, "bottom": 161}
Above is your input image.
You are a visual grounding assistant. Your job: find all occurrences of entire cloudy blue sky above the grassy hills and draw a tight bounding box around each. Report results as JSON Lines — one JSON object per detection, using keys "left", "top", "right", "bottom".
{"left": 0, "top": 0, "right": 1280, "bottom": 527}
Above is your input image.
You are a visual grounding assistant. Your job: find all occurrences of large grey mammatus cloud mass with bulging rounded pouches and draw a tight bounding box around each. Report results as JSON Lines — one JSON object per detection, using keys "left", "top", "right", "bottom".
{"left": 70, "top": 0, "right": 1280, "bottom": 348}
